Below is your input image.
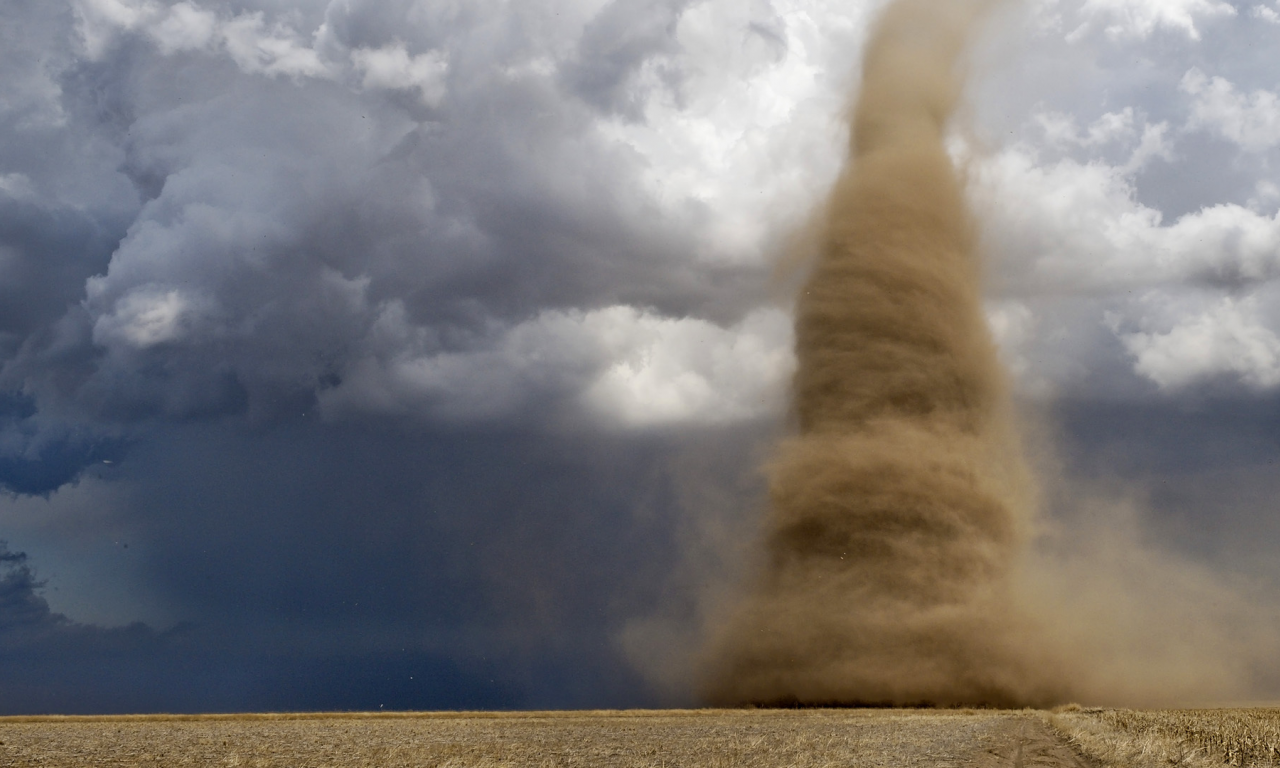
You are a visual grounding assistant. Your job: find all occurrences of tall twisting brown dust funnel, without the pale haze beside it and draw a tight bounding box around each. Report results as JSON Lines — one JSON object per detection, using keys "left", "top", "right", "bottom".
{"left": 707, "top": 0, "right": 1066, "bottom": 705}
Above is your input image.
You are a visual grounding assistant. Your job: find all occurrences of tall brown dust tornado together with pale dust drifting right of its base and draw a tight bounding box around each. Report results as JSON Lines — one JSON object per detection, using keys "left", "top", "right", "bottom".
{"left": 703, "top": 0, "right": 1276, "bottom": 707}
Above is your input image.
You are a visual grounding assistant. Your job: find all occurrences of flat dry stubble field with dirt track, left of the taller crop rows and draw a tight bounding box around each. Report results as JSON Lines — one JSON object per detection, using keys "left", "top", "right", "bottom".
{"left": 0, "top": 710, "right": 1087, "bottom": 768}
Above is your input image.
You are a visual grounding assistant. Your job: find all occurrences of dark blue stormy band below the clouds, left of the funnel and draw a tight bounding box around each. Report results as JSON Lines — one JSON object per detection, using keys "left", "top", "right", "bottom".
{"left": 0, "top": 417, "right": 765, "bottom": 710}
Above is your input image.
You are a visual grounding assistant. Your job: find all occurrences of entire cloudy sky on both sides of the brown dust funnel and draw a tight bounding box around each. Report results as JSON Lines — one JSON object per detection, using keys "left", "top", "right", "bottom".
{"left": 0, "top": 0, "right": 1280, "bottom": 713}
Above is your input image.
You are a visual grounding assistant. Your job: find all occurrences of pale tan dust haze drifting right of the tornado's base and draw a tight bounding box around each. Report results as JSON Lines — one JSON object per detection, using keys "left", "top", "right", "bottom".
{"left": 1018, "top": 473, "right": 1280, "bottom": 707}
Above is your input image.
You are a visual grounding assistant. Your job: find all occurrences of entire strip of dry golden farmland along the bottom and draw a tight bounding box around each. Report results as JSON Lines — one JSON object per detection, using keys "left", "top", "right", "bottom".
{"left": 0, "top": 708, "right": 1280, "bottom": 768}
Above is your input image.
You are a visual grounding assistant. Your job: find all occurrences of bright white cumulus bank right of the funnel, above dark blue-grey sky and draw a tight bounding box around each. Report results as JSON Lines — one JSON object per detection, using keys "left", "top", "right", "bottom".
{"left": 970, "top": 107, "right": 1280, "bottom": 393}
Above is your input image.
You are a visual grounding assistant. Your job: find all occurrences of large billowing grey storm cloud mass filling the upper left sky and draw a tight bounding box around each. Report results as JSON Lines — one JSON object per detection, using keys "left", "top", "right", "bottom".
{"left": 6, "top": 1, "right": 778, "bottom": 432}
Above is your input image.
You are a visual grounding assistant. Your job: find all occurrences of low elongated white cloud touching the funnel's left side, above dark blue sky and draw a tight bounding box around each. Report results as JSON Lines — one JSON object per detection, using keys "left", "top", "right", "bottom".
{"left": 320, "top": 306, "right": 794, "bottom": 428}
